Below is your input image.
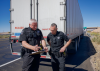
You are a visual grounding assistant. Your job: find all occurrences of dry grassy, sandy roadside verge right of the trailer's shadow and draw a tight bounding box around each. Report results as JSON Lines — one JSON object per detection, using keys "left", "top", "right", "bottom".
{"left": 87, "top": 31, "right": 100, "bottom": 71}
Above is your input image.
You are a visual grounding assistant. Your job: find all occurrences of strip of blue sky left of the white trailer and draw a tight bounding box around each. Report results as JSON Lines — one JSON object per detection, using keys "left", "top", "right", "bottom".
{"left": 0, "top": 0, "right": 10, "bottom": 32}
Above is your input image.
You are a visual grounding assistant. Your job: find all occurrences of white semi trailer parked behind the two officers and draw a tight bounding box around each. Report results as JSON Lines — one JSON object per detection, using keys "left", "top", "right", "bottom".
{"left": 9, "top": 0, "right": 83, "bottom": 58}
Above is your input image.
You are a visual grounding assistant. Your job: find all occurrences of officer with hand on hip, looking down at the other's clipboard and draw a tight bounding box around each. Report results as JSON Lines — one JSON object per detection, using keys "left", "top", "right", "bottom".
{"left": 47, "top": 23, "right": 71, "bottom": 71}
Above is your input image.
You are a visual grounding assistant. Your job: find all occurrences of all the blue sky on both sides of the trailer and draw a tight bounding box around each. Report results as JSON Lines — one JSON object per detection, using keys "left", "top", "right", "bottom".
{"left": 0, "top": 0, "right": 100, "bottom": 32}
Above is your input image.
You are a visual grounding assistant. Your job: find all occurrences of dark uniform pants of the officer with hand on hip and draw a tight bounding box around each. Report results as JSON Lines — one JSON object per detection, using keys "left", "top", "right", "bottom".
{"left": 51, "top": 54, "right": 65, "bottom": 71}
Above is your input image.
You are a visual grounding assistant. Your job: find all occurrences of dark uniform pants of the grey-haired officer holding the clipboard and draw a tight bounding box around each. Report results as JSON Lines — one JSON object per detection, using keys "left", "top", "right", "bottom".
{"left": 22, "top": 53, "right": 40, "bottom": 71}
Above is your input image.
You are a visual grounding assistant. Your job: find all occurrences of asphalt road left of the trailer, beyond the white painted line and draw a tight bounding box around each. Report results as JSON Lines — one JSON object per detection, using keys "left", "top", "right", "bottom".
{"left": 0, "top": 38, "right": 20, "bottom": 65}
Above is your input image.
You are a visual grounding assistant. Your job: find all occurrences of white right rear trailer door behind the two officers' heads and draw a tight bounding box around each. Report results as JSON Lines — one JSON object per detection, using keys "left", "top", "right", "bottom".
{"left": 37, "top": 0, "right": 65, "bottom": 37}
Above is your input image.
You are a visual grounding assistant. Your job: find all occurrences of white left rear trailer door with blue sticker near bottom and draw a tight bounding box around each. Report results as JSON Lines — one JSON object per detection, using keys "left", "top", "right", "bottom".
{"left": 10, "top": 0, "right": 30, "bottom": 38}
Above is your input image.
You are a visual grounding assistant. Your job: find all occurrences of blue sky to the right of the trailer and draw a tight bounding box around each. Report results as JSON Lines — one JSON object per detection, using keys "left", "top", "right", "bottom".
{"left": 78, "top": 0, "right": 100, "bottom": 27}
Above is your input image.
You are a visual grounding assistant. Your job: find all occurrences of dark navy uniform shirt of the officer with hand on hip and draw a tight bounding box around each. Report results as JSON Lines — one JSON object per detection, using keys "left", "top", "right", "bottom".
{"left": 47, "top": 31, "right": 69, "bottom": 52}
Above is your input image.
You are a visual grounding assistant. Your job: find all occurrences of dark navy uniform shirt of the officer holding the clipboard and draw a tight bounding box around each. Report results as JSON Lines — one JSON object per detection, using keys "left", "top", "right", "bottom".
{"left": 19, "top": 27, "right": 44, "bottom": 50}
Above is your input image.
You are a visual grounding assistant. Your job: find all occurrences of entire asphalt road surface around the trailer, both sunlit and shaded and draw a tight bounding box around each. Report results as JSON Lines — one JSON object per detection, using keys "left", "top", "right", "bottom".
{"left": 0, "top": 36, "right": 96, "bottom": 71}
